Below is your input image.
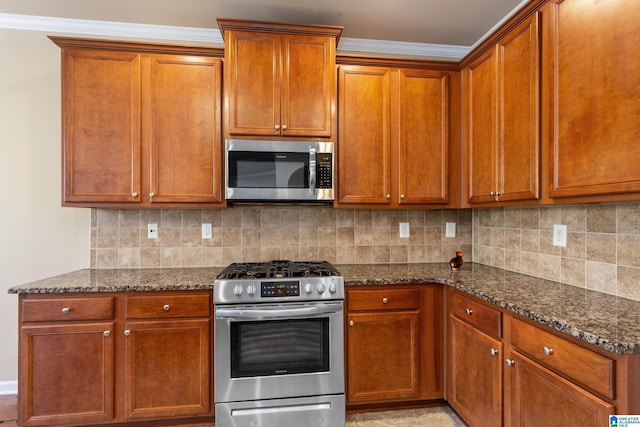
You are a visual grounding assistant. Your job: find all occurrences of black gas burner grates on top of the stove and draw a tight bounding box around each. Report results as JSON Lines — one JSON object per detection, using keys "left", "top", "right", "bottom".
{"left": 218, "top": 260, "right": 340, "bottom": 279}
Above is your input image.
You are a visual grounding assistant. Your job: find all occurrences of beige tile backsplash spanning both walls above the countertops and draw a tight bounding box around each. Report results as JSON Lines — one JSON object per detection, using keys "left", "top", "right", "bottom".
{"left": 90, "top": 203, "right": 640, "bottom": 301}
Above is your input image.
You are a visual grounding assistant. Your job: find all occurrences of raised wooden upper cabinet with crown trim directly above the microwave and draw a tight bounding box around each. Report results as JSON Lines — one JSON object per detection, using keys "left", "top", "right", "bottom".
{"left": 218, "top": 19, "right": 342, "bottom": 138}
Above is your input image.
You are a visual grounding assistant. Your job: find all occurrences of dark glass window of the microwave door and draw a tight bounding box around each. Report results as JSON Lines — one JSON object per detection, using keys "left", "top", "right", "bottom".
{"left": 229, "top": 151, "right": 309, "bottom": 188}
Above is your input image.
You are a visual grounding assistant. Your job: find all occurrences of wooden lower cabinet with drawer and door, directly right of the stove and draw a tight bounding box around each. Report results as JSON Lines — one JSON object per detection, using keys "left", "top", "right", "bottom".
{"left": 345, "top": 285, "right": 444, "bottom": 409}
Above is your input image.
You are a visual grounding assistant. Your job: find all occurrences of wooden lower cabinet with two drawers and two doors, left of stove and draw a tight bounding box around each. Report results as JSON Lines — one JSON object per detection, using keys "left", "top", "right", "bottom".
{"left": 18, "top": 291, "right": 213, "bottom": 426}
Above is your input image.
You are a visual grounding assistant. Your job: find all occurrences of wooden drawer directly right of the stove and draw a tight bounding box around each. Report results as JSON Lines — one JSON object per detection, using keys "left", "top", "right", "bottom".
{"left": 347, "top": 288, "right": 420, "bottom": 311}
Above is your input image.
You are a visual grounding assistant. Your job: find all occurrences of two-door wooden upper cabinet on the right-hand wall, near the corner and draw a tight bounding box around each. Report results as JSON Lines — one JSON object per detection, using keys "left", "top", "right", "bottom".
{"left": 463, "top": 13, "right": 540, "bottom": 204}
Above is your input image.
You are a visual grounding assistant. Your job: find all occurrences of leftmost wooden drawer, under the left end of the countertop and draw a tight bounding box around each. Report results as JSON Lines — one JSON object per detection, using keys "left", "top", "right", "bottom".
{"left": 21, "top": 297, "right": 114, "bottom": 322}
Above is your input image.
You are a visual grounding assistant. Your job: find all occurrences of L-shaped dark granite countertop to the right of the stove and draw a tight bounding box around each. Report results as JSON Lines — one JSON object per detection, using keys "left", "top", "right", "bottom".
{"left": 337, "top": 263, "right": 640, "bottom": 354}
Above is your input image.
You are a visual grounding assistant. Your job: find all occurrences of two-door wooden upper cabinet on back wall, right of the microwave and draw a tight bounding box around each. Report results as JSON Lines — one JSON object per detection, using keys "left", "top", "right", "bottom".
{"left": 336, "top": 65, "right": 449, "bottom": 207}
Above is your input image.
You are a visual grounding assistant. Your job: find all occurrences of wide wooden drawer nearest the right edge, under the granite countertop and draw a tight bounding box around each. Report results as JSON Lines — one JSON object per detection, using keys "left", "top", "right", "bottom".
{"left": 511, "top": 319, "right": 615, "bottom": 399}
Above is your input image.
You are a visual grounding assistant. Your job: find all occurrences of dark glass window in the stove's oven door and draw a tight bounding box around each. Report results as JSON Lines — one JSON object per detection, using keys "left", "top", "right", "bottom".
{"left": 231, "top": 318, "right": 329, "bottom": 378}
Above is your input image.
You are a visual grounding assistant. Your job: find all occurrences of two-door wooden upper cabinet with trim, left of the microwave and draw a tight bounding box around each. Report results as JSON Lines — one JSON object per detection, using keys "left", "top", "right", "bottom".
{"left": 52, "top": 37, "right": 222, "bottom": 206}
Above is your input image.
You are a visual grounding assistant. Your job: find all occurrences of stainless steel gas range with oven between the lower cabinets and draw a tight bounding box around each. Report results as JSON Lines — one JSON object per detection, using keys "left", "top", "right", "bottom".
{"left": 214, "top": 261, "right": 345, "bottom": 427}
